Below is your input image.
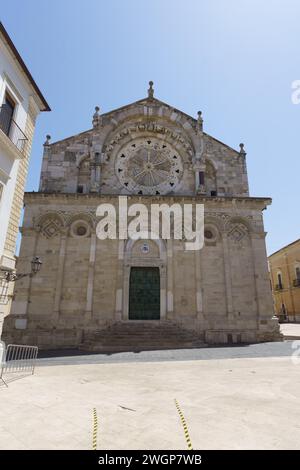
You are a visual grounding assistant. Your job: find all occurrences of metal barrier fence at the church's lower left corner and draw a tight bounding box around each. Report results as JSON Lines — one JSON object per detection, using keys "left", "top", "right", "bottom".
{"left": 0, "top": 344, "right": 38, "bottom": 386}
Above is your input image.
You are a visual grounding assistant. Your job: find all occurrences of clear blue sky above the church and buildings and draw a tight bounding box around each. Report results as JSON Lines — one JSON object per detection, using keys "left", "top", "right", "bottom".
{"left": 0, "top": 0, "right": 300, "bottom": 253}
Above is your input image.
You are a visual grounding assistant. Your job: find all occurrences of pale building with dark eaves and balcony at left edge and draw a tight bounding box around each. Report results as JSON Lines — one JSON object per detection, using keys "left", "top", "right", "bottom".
{"left": 0, "top": 23, "right": 50, "bottom": 338}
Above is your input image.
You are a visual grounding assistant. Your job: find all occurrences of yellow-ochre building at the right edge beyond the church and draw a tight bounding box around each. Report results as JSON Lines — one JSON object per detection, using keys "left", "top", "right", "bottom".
{"left": 269, "top": 240, "right": 300, "bottom": 321}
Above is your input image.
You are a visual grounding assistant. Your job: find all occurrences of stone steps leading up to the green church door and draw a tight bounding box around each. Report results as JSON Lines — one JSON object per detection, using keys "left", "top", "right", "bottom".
{"left": 80, "top": 320, "right": 206, "bottom": 353}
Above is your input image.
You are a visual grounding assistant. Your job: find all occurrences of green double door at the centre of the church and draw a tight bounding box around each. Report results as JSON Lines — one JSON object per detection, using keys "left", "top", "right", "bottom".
{"left": 129, "top": 267, "right": 160, "bottom": 320}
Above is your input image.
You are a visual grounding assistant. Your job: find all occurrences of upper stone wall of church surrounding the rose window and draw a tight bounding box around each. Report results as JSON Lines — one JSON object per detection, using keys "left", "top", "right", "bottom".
{"left": 40, "top": 100, "right": 249, "bottom": 196}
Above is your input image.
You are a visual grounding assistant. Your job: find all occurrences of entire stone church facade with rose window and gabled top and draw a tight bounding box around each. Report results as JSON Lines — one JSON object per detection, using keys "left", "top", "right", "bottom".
{"left": 4, "top": 82, "right": 280, "bottom": 350}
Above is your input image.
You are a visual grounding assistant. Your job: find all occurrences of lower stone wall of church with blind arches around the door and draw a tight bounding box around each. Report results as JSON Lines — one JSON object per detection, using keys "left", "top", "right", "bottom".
{"left": 4, "top": 193, "right": 278, "bottom": 347}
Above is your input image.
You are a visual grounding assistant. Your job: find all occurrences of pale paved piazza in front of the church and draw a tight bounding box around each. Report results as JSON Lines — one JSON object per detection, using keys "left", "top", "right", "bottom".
{"left": 0, "top": 341, "right": 300, "bottom": 450}
